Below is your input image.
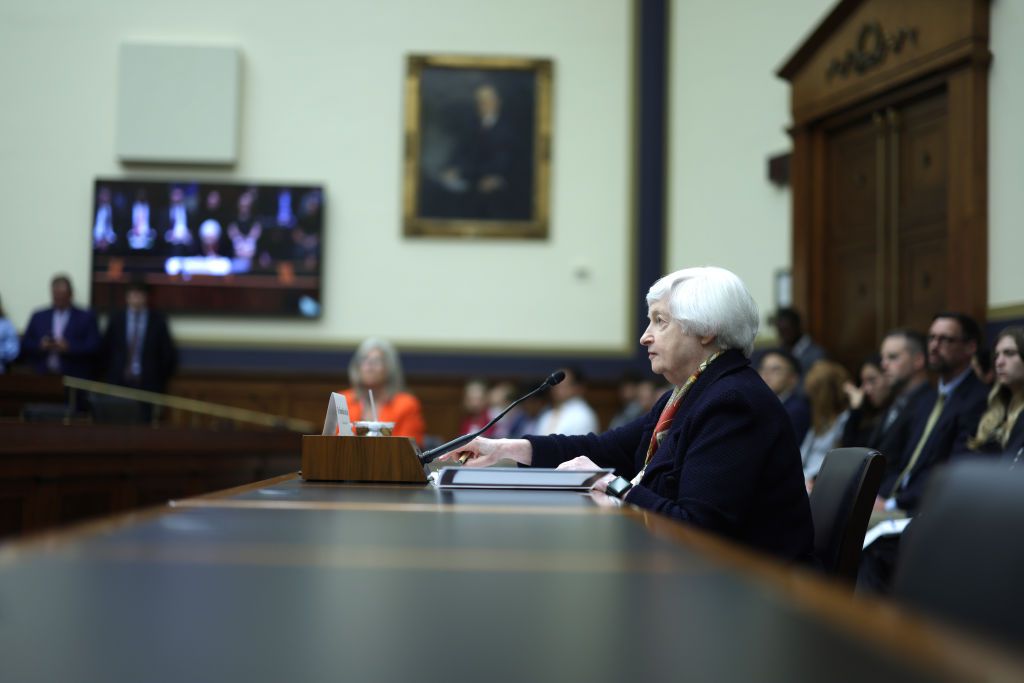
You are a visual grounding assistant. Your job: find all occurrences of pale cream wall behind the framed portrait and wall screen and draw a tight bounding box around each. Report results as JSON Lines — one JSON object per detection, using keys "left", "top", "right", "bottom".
{"left": 0, "top": 0, "right": 634, "bottom": 351}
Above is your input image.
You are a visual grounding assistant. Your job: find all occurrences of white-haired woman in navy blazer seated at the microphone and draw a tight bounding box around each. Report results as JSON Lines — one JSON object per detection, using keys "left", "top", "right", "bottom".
{"left": 445, "top": 267, "right": 814, "bottom": 563}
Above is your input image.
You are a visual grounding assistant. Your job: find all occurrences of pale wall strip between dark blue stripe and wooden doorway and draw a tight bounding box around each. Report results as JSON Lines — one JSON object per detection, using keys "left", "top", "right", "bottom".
{"left": 668, "top": 0, "right": 834, "bottom": 336}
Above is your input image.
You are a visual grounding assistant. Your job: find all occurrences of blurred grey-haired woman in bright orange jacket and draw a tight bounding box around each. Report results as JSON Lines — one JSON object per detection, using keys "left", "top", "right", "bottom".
{"left": 342, "top": 337, "right": 426, "bottom": 445}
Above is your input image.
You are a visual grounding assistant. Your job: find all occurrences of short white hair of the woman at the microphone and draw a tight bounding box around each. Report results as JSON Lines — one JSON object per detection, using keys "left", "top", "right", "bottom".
{"left": 647, "top": 266, "right": 760, "bottom": 357}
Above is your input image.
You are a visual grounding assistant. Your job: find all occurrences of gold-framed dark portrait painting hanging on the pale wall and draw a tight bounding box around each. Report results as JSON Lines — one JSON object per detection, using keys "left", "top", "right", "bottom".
{"left": 402, "top": 55, "right": 552, "bottom": 239}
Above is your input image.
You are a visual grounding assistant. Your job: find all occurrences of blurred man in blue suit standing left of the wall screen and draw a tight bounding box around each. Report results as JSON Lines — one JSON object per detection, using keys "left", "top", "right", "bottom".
{"left": 22, "top": 274, "right": 99, "bottom": 378}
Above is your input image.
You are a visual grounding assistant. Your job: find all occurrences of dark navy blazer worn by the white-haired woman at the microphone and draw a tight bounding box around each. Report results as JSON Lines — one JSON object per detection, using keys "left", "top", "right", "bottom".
{"left": 526, "top": 349, "right": 814, "bottom": 563}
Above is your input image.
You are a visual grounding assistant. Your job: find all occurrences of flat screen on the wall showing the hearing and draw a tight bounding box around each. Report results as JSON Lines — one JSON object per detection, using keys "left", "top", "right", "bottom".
{"left": 90, "top": 178, "right": 324, "bottom": 317}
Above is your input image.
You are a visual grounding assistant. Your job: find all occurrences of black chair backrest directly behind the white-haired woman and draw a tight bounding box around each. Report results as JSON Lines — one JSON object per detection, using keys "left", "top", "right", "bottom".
{"left": 811, "top": 447, "right": 885, "bottom": 586}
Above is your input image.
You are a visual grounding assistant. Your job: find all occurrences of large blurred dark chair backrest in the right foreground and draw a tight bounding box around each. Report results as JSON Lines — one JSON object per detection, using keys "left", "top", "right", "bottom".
{"left": 893, "top": 459, "right": 1024, "bottom": 647}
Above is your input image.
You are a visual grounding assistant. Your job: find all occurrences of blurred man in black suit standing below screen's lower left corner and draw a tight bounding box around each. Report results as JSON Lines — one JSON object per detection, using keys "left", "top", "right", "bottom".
{"left": 103, "top": 283, "right": 178, "bottom": 392}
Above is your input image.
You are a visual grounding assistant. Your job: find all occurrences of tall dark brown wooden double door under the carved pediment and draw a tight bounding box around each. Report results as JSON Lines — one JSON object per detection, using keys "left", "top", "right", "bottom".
{"left": 819, "top": 91, "right": 949, "bottom": 370}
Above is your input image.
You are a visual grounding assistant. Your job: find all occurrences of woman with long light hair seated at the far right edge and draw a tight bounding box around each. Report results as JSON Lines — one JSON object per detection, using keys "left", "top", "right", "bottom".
{"left": 967, "top": 326, "right": 1024, "bottom": 458}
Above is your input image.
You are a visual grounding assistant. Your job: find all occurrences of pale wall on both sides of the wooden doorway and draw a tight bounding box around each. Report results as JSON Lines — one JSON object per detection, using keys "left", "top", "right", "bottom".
{"left": 668, "top": 0, "right": 1024, "bottom": 337}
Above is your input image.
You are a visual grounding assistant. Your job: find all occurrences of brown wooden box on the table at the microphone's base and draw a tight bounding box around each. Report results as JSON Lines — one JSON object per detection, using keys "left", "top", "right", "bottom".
{"left": 302, "top": 434, "right": 427, "bottom": 484}
